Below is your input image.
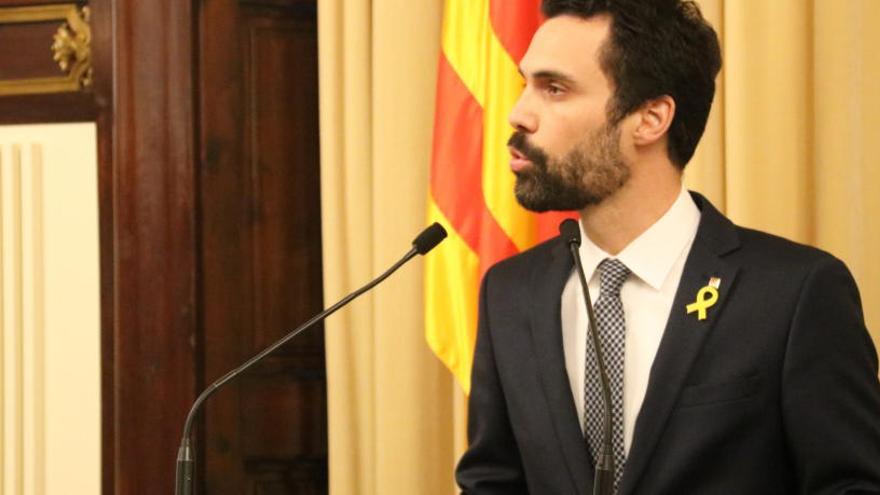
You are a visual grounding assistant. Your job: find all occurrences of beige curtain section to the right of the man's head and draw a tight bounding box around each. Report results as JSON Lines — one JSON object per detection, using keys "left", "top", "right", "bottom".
{"left": 685, "top": 0, "right": 880, "bottom": 342}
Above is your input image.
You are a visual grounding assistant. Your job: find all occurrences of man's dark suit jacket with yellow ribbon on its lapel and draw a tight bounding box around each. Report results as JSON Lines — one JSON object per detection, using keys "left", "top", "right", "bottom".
{"left": 456, "top": 194, "right": 880, "bottom": 495}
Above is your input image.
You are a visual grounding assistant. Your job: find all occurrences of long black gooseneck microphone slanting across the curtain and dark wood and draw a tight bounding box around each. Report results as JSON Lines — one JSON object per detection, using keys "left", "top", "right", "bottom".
{"left": 174, "top": 222, "right": 446, "bottom": 495}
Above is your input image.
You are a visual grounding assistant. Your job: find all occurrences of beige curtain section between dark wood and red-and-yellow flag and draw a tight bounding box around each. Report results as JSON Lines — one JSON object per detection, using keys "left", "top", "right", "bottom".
{"left": 318, "top": 0, "right": 462, "bottom": 495}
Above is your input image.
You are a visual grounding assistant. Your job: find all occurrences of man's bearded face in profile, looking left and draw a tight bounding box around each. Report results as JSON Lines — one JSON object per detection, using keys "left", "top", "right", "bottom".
{"left": 508, "top": 16, "right": 629, "bottom": 211}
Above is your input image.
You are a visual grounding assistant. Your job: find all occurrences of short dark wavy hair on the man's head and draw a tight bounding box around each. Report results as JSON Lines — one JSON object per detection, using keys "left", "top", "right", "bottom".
{"left": 541, "top": 0, "right": 721, "bottom": 168}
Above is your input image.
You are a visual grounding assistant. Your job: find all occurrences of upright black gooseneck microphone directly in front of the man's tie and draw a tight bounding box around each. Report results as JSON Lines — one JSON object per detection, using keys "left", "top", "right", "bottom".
{"left": 559, "top": 218, "right": 614, "bottom": 495}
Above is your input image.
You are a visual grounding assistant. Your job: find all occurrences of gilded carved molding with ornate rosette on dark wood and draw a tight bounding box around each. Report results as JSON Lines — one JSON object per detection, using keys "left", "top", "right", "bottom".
{"left": 0, "top": 3, "right": 92, "bottom": 96}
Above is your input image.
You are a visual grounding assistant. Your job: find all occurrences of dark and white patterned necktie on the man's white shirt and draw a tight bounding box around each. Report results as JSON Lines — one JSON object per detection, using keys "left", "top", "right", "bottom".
{"left": 584, "top": 258, "right": 630, "bottom": 493}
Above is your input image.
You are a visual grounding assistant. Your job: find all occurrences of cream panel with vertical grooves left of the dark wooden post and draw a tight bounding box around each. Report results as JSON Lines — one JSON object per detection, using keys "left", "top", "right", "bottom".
{"left": 0, "top": 124, "right": 101, "bottom": 495}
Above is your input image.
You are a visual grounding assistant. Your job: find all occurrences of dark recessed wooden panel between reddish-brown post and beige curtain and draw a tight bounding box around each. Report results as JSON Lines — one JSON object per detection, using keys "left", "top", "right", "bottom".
{"left": 201, "top": 0, "right": 327, "bottom": 494}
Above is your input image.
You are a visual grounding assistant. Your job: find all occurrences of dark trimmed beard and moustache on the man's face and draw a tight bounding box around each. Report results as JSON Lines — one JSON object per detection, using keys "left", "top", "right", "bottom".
{"left": 507, "top": 124, "right": 630, "bottom": 213}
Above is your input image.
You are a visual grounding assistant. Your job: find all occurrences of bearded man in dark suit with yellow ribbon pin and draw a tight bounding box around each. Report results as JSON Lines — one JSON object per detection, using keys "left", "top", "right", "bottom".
{"left": 456, "top": 0, "right": 880, "bottom": 495}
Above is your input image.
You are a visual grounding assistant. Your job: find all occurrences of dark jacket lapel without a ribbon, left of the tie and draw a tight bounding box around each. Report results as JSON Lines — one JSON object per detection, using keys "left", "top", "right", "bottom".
{"left": 531, "top": 242, "right": 593, "bottom": 493}
